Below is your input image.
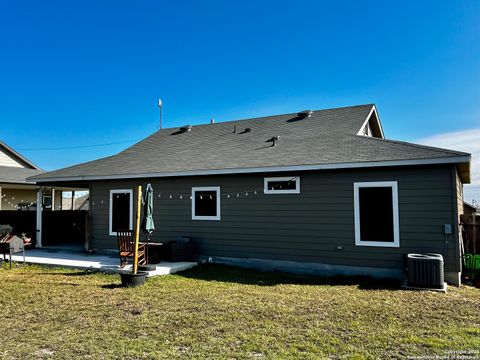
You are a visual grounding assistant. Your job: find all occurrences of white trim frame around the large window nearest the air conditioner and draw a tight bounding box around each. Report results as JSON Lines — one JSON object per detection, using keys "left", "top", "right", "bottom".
{"left": 353, "top": 181, "right": 400, "bottom": 247}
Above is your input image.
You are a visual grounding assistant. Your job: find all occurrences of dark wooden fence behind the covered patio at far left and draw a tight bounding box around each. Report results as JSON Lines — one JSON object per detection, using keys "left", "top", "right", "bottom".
{"left": 0, "top": 210, "right": 89, "bottom": 246}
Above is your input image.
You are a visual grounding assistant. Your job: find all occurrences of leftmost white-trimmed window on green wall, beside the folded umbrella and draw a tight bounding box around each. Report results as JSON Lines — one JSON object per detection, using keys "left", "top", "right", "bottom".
{"left": 109, "top": 189, "right": 133, "bottom": 235}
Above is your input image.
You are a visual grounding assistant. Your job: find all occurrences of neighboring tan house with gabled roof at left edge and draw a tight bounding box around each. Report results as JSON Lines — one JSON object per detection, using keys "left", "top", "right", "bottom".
{"left": 0, "top": 141, "right": 43, "bottom": 210}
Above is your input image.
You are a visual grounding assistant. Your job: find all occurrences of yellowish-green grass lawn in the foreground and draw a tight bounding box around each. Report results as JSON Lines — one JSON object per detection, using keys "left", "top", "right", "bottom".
{"left": 0, "top": 265, "right": 480, "bottom": 359}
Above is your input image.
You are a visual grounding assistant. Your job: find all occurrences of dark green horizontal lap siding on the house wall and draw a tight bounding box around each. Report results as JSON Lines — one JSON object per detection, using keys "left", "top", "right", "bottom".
{"left": 90, "top": 166, "right": 458, "bottom": 271}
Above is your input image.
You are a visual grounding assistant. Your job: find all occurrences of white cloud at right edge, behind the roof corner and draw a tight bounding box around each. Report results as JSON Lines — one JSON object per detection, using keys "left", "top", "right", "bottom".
{"left": 416, "top": 128, "right": 480, "bottom": 203}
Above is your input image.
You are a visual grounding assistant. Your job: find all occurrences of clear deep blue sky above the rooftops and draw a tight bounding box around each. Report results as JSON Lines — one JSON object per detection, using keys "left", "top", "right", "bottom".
{"left": 0, "top": 0, "right": 480, "bottom": 200}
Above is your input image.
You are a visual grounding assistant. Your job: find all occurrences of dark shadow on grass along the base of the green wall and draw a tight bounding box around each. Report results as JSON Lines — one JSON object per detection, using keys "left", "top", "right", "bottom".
{"left": 177, "top": 264, "right": 401, "bottom": 290}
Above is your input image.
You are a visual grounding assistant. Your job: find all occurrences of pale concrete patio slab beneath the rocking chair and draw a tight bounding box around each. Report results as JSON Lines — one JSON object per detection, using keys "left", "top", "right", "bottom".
{"left": 12, "top": 248, "right": 198, "bottom": 276}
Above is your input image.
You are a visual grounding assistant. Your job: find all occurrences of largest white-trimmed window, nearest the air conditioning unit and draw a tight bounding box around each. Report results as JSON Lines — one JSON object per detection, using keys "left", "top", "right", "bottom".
{"left": 354, "top": 181, "right": 400, "bottom": 247}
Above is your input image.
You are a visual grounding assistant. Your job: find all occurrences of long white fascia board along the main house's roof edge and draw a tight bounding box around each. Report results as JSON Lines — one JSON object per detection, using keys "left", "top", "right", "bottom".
{"left": 31, "top": 156, "right": 470, "bottom": 184}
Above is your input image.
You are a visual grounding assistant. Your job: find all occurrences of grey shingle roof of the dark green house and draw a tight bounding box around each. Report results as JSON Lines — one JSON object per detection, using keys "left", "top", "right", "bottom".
{"left": 28, "top": 105, "right": 470, "bottom": 182}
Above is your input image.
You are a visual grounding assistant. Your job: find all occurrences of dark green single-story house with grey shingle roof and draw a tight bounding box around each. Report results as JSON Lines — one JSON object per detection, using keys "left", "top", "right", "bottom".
{"left": 31, "top": 105, "right": 470, "bottom": 284}
